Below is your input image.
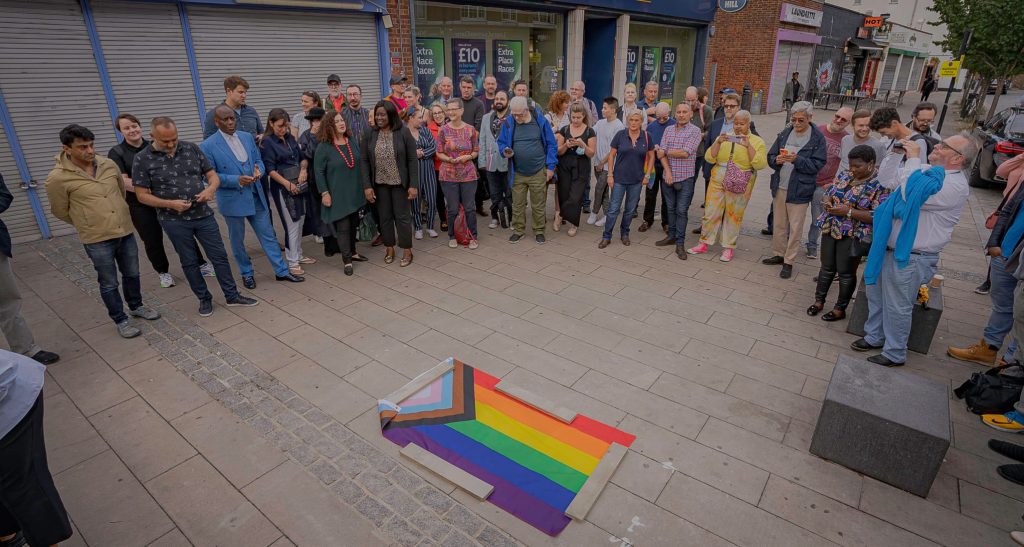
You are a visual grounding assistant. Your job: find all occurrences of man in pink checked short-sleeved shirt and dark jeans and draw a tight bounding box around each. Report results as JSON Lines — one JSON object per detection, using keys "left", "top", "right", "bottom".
{"left": 654, "top": 102, "right": 700, "bottom": 260}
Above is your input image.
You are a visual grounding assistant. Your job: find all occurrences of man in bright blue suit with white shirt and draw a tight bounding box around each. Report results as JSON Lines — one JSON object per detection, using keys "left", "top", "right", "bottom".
{"left": 200, "top": 104, "right": 305, "bottom": 290}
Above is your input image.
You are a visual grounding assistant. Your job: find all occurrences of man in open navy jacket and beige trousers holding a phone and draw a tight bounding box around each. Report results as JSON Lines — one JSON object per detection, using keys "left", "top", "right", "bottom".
{"left": 761, "top": 100, "right": 828, "bottom": 280}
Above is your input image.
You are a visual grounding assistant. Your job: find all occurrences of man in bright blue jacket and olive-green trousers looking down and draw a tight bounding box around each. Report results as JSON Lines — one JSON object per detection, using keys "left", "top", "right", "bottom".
{"left": 498, "top": 96, "right": 558, "bottom": 245}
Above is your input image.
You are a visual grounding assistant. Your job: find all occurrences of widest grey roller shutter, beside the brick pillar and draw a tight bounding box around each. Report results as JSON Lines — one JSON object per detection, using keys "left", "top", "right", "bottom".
{"left": 188, "top": 5, "right": 381, "bottom": 127}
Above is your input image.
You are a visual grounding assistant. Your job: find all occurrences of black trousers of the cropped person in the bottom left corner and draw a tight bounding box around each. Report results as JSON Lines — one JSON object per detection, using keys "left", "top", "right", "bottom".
{"left": 0, "top": 392, "right": 72, "bottom": 546}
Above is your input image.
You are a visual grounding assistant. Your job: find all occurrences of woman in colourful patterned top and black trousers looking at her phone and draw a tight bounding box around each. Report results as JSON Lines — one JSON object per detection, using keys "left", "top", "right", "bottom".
{"left": 807, "top": 144, "right": 889, "bottom": 321}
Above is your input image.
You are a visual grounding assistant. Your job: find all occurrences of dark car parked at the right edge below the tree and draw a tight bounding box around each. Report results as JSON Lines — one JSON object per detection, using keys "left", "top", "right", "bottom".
{"left": 970, "top": 107, "right": 1024, "bottom": 187}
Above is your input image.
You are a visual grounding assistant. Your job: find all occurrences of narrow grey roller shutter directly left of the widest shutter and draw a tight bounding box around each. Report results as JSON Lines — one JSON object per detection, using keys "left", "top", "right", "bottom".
{"left": 92, "top": 0, "right": 203, "bottom": 143}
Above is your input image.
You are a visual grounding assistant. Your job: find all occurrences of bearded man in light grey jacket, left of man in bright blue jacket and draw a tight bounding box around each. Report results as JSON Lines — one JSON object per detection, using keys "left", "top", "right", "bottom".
{"left": 477, "top": 91, "right": 512, "bottom": 228}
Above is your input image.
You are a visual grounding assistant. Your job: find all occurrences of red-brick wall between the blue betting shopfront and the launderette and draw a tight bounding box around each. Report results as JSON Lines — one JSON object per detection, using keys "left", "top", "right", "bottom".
{"left": 705, "top": 0, "right": 822, "bottom": 112}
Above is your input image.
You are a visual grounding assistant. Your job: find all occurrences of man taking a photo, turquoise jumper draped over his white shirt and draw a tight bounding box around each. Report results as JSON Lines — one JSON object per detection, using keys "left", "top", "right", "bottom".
{"left": 850, "top": 133, "right": 978, "bottom": 367}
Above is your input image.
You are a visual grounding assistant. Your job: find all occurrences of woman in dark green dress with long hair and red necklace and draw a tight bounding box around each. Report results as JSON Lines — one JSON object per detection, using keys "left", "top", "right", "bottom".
{"left": 313, "top": 111, "right": 367, "bottom": 276}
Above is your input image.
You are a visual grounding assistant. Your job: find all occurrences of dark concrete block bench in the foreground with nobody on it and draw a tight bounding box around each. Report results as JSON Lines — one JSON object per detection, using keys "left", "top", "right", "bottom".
{"left": 811, "top": 355, "right": 950, "bottom": 498}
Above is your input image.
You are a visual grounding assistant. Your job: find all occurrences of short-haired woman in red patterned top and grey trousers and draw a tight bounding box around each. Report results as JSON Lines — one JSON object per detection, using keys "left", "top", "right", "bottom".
{"left": 437, "top": 98, "right": 480, "bottom": 249}
